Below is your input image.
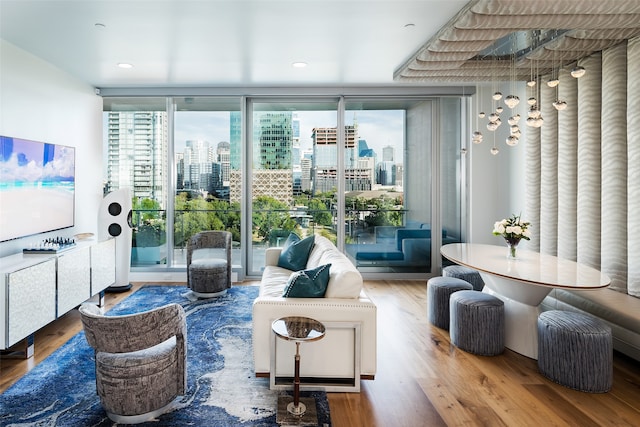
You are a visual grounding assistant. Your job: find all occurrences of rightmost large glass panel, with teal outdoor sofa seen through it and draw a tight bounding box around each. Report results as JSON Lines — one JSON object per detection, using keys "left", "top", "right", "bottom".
{"left": 344, "top": 98, "right": 462, "bottom": 274}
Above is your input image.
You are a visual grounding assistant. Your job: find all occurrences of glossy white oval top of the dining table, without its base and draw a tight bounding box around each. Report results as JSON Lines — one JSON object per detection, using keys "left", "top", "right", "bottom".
{"left": 440, "top": 243, "right": 611, "bottom": 290}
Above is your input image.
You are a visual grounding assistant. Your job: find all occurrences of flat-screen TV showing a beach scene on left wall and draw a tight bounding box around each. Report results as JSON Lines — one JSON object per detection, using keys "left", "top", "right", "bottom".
{"left": 0, "top": 136, "right": 75, "bottom": 241}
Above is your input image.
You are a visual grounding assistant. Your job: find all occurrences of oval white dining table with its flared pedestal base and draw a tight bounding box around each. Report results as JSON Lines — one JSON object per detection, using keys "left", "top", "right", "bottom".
{"left": 440, "top": 243, "right": 611, "bottom": 359}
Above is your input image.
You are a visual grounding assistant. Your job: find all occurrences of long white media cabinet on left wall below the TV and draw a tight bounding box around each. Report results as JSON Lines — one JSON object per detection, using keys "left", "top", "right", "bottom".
{"left": 0, "top": 239, "right": 116, "bottom": 357}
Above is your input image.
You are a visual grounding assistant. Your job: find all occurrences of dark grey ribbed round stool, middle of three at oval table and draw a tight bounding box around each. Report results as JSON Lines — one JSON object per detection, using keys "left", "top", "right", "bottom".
{"left": 449, "top": 291, "right": 504, "bottom": 356}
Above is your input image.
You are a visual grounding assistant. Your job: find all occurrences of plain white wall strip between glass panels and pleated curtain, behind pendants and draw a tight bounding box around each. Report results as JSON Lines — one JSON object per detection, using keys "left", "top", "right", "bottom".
{"left": 468, "top": 82, "right": 528, "bottom": 246}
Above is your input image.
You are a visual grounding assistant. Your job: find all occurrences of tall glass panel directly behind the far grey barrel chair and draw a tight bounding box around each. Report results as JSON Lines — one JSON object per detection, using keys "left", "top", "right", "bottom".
{"left": 172, "top": 97, "right": 243, "bottom": 269}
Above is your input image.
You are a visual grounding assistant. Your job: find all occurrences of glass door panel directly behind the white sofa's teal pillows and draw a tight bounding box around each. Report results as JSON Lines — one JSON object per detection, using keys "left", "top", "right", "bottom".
{"left": 247, "top": 99, "right": 338, "bottom": 275}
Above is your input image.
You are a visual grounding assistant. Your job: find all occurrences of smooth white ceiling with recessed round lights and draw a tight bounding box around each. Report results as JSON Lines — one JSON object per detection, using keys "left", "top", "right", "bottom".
{"left": 0, "top": 0, "right": 467, "bottom": 88}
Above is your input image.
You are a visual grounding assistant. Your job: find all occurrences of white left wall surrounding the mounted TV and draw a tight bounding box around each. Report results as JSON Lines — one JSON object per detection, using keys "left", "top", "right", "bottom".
{"left": 0, "top": 40, "right": 102, "bottom": 256}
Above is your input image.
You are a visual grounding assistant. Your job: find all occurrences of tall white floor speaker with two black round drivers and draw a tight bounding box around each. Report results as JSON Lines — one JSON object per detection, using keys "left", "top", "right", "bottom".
{"left": 98, "top": 188, "right": 133, "bottom": 292}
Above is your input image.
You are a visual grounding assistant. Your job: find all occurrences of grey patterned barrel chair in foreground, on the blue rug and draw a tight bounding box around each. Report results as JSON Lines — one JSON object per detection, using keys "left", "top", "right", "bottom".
{"left": 79, "top": 303, "right": 187, "bottom": 424}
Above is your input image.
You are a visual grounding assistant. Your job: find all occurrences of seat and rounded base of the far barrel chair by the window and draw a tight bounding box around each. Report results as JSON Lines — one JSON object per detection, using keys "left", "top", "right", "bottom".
{"left": 189, "top": 258, "right": 228, "bottom": 298}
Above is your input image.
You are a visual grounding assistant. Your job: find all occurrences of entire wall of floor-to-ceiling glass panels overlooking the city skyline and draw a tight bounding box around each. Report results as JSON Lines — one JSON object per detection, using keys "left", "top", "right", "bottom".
{"left": 104, "top": 91, "right": 465, "bottom": 277}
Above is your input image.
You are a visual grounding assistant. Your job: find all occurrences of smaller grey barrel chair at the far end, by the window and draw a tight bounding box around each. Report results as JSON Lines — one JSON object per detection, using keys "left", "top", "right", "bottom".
{"left": 187, "top": 231, "right": 231, "bottom": 298}
